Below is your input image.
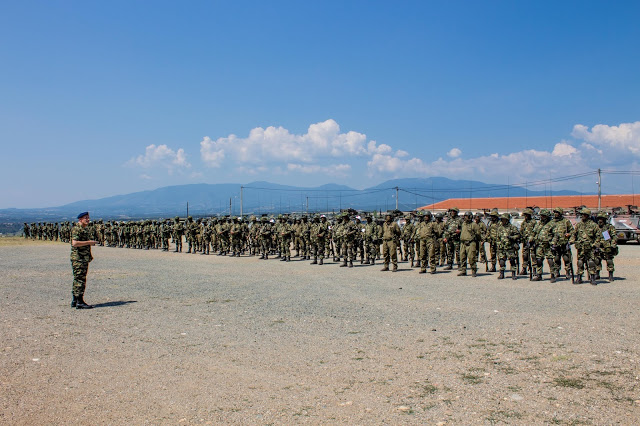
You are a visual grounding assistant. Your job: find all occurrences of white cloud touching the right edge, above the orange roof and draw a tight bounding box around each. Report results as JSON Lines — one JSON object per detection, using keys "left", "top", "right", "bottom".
{"left": 571, "top": 121, "right": 640, "bottom": 155}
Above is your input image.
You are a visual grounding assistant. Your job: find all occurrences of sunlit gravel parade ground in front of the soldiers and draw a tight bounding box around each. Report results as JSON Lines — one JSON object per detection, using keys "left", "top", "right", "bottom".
{"left": 0, "top": 240, "right": 640, "bottom": 425}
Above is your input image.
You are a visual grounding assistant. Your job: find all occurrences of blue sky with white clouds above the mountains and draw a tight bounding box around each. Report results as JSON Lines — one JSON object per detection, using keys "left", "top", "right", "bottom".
{"left": 0, "top": 1, "right": 640, "bottom": 208}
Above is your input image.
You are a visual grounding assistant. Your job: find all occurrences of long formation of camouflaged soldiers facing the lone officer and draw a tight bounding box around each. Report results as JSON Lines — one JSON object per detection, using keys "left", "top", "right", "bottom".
{"left": 25, "top": 208, "right": 618, "bottom": 284}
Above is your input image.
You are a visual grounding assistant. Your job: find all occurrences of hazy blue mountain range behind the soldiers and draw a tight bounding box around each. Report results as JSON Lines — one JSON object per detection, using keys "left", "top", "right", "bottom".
{"left": 0, "top": 177, "right": 592, "bottom": 233}
